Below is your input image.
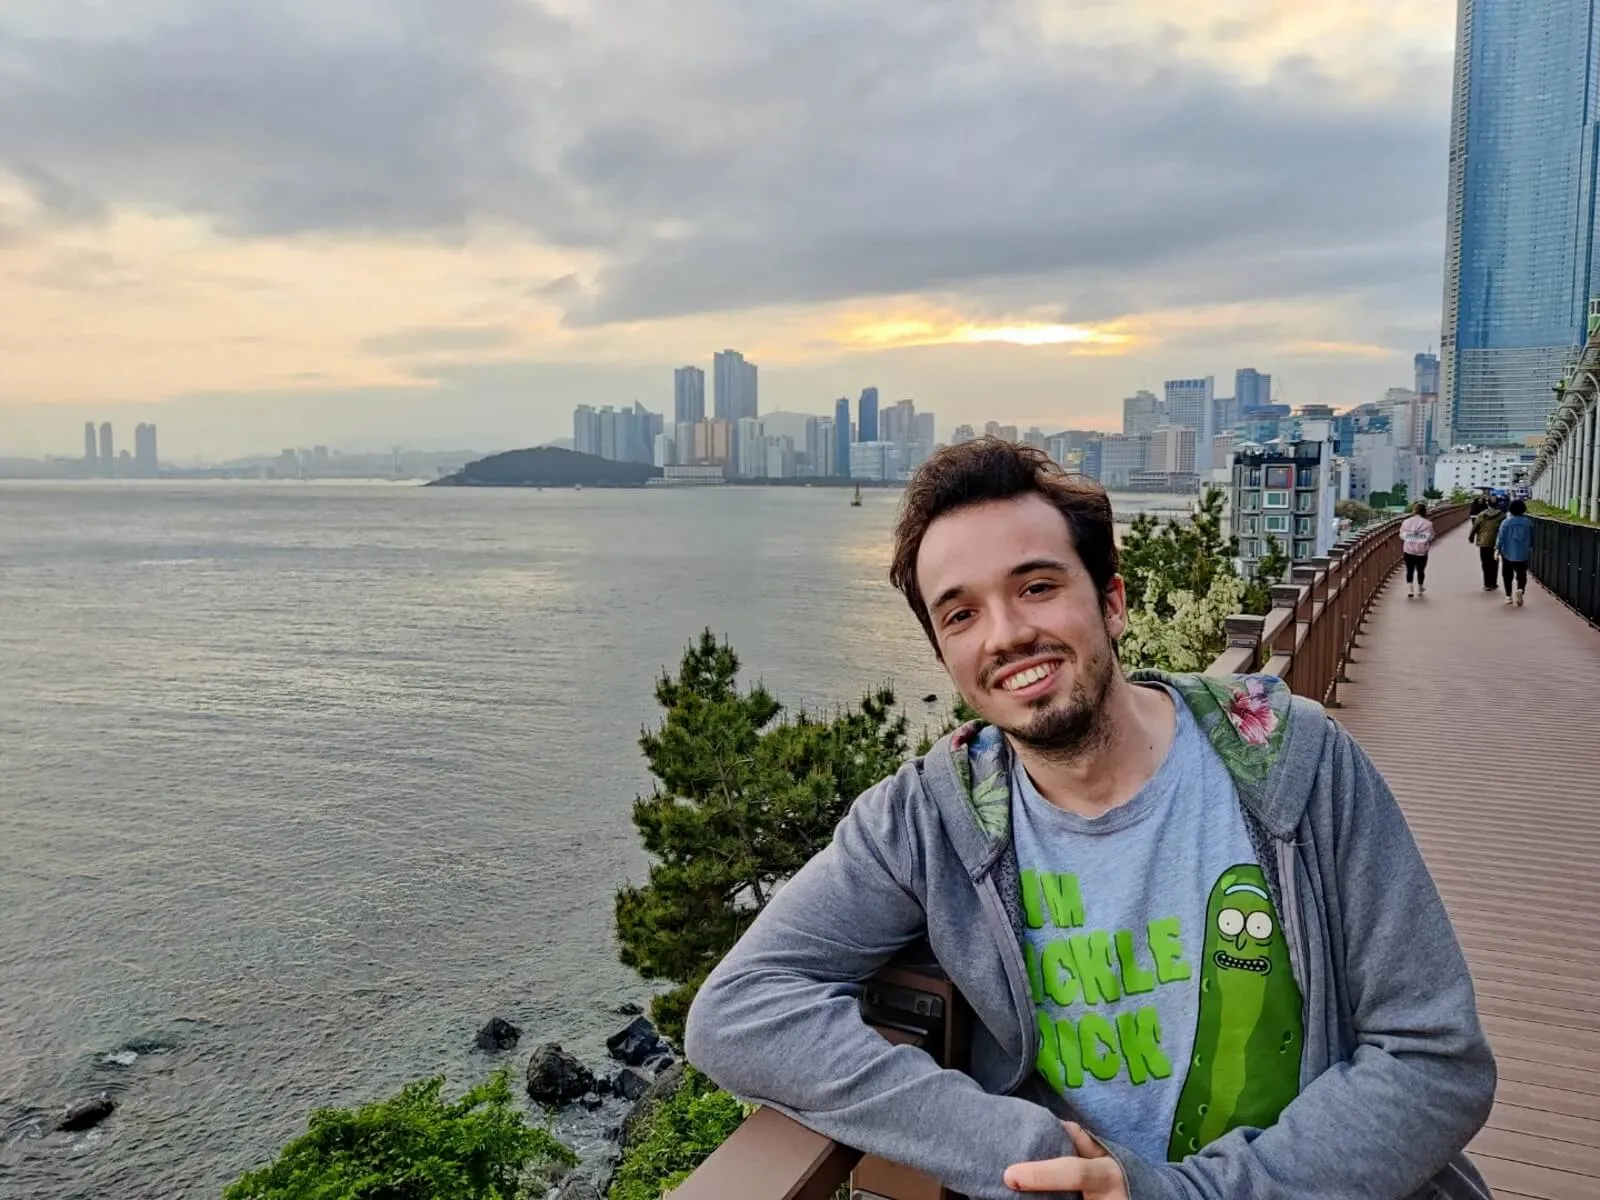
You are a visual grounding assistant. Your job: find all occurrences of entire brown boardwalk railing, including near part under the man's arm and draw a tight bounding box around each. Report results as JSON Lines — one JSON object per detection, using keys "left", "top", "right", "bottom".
{"left": 670, "top": 504, "right": 1467, "bottom": 1200}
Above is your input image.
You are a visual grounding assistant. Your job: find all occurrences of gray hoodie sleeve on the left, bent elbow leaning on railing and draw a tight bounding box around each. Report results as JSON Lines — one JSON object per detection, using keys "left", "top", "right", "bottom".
{"left": 685, "top": 766, "right": 1072, "bottom": 1200}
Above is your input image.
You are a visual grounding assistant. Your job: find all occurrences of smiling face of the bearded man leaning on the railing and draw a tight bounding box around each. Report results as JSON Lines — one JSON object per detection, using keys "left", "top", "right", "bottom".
{"left": 917, "top": 496, "right": 1126, "bottom": 754}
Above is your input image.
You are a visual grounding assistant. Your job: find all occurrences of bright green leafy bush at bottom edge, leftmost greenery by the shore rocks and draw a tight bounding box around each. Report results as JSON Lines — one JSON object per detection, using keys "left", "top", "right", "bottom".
{"left": 222, "top": 1072, "right": 578, "bottom": 1200}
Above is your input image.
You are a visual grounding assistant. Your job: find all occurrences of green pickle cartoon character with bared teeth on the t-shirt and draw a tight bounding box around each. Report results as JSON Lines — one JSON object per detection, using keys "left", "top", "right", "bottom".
{"left": 1166, "top": 864, "right": 1304, "bottom": 1162}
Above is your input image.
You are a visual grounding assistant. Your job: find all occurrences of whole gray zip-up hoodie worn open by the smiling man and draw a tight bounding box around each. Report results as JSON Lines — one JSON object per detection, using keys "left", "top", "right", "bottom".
{"left": 685, "top": 672, "right": 1494, "bottom": 1200}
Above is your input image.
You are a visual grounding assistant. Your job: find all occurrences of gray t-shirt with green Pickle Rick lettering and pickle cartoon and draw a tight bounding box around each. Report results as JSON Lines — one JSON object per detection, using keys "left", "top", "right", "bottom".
{"left": 1011, "top": 691, "right": 1302, "bottom": 1162}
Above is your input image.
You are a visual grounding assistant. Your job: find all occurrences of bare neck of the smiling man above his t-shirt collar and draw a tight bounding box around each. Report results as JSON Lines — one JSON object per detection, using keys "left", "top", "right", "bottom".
{"left": 1011, "top": 672, "right": 1178, "bottom": 818}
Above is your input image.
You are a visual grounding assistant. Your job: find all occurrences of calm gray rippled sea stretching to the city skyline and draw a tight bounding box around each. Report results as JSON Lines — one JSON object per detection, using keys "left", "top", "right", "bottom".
{"left": 0, "top": 482, "right": 1177, "bottom": 1198}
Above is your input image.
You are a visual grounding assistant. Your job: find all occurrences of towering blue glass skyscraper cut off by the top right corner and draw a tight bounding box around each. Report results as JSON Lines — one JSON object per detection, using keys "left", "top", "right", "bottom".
{"left": 1440, "top": 0, "right": 1600, "bottom": 445}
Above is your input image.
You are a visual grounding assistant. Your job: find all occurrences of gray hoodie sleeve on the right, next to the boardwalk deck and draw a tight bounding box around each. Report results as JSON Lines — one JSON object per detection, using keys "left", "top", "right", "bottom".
{"left": 1109, "top": 725, "right": 1496, "bottom": 1200}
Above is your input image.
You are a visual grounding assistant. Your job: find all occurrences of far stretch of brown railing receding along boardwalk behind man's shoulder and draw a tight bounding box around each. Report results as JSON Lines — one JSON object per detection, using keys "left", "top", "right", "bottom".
{"left": 1206, "top": 504, "right": 1467, "bottom": 709}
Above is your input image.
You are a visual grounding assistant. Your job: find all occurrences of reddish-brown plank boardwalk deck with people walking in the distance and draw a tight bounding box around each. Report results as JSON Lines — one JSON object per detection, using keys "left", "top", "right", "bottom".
{"left": 1336, "top": 530, "right": 1600, "bottom": 1200}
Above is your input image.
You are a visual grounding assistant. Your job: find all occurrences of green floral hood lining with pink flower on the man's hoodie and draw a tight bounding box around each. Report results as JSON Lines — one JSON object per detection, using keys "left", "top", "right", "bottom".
{"left": 950, "top": 670, "right": 1293, "bottom": 842}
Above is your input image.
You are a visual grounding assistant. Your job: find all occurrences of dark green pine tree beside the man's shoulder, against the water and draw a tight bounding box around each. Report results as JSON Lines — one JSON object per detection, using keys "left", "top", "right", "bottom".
{"left": 616, "top": 629, "right": 907, "bottom": 1040}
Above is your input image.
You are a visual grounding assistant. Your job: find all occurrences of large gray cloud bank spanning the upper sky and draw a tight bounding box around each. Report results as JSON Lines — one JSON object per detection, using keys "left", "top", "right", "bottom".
{"left": 0, "top": 0, "right": 1448, "bottom": 325}
